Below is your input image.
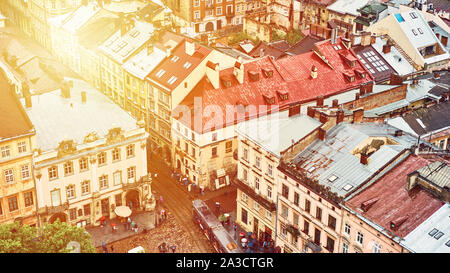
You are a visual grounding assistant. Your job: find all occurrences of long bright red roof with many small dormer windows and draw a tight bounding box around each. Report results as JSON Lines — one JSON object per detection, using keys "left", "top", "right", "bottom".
{"left": 174, "top": 37, "right": 373, "bottom": 132}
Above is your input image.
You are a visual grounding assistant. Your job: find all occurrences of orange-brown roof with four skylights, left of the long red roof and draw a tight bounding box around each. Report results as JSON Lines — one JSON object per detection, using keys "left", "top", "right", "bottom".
{"left": 147, "top": 38, "right": 212, "bottom": 90}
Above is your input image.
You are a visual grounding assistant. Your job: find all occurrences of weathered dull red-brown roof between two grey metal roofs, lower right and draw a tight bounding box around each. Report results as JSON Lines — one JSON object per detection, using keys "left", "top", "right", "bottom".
{"left": 346, "top": 156, "right": 444, "bottom": 237}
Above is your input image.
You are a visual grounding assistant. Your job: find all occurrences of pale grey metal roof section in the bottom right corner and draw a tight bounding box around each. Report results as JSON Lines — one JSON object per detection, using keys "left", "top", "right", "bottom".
{"left": 400, "top": 203, "right": 450, "bottom": 253}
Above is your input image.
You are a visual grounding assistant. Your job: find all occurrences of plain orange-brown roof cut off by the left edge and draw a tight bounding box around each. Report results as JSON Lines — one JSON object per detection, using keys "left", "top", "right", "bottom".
{"left": 0, "top": 70, "right": 33, "bottom": 138}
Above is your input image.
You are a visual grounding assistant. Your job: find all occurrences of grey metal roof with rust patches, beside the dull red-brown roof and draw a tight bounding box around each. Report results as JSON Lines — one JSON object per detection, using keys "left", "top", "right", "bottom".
{"left": 292, "top": 123, "right": 417, "bottom": 196}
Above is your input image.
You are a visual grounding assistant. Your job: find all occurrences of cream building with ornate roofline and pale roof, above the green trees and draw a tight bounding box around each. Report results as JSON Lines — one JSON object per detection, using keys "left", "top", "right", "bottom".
{"left": 22, "top": 79, "right": 151, "bottom": 226}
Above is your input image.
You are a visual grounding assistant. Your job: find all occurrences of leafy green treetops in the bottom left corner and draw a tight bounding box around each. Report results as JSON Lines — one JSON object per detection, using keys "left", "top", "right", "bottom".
{"left": 0, "top": 220, "right": 96, "bottom": 253}
